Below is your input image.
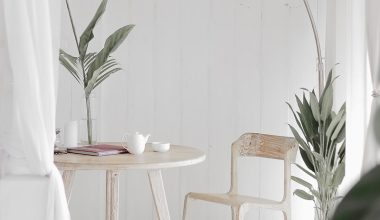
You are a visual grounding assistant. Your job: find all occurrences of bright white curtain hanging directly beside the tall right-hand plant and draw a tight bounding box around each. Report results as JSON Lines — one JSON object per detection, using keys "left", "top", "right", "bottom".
{"left": 337, "top": 0, "right": 371, "bottom": 193}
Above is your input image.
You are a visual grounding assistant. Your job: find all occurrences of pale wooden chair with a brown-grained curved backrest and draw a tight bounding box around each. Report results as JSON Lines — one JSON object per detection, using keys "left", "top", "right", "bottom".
{"left": 183, "top": 133, "right": 298, "bottom": 220}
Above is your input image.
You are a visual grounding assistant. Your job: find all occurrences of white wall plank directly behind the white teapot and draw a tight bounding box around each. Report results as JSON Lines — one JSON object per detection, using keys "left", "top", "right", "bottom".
{"left": 123, "top": 0, "right": 155, "bottom": 219}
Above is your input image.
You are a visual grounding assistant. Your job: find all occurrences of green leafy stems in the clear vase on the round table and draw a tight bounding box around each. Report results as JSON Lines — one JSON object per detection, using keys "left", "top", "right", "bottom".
{"left": 59, "top": 0, "right": 134, "bottom": 144}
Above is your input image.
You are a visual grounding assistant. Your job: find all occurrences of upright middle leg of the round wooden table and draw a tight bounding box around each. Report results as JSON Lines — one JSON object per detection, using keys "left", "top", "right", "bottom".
{"left": 106, "top": 170, "right": 119, "bottom": 220}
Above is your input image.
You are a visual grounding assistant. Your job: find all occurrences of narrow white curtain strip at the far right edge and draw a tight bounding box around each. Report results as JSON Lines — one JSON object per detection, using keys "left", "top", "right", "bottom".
{"left": 363, "top": 0, "right": 380, "bottom": 173}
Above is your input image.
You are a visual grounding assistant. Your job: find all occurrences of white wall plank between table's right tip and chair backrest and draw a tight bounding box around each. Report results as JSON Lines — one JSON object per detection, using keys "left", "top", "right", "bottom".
{"left": 208, "top": 0, "right": 237, "bottom": 220}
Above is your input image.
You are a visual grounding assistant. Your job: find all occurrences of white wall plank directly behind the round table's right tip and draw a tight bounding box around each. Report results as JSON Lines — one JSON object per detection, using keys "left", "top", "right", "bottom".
{"left": 178, "top": 0, "right": 210, "bottom": 220}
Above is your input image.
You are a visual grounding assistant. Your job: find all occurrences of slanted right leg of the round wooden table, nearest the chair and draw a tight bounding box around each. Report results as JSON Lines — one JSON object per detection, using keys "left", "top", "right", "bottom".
{"left": 148, "top": 170, "right": 170, "bottom": 220}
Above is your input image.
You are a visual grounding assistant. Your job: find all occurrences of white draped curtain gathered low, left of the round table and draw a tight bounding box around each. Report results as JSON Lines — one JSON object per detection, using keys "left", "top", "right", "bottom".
{"left": 0, "top": 0, "right": 70, "bottom": 220}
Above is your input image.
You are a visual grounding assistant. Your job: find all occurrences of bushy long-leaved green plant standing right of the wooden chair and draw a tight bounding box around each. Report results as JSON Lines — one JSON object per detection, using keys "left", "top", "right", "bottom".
{"left": 287, "top": 71, "right": 346, "bottom": 220}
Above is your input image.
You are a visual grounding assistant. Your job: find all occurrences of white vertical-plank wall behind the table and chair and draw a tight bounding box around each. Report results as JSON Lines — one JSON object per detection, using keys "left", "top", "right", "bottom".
{"left": 57, "top": 0, "right": 323, "bottom": 220}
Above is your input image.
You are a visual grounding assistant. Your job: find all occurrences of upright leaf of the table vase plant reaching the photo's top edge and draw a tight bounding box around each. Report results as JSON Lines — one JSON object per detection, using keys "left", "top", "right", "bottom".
{"left": 79, "top": 0, "right": 107, "bottom": 59}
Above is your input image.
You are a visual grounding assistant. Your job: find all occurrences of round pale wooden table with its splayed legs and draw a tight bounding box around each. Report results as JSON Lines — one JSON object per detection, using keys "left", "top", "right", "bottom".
{"left": 54, "top": 143, "right": 206, "bottom": 220}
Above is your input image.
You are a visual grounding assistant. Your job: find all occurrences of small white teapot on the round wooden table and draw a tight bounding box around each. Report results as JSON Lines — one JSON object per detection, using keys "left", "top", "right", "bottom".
{"left": 123, "top": 132, "right": 150, "bottom": 155}
